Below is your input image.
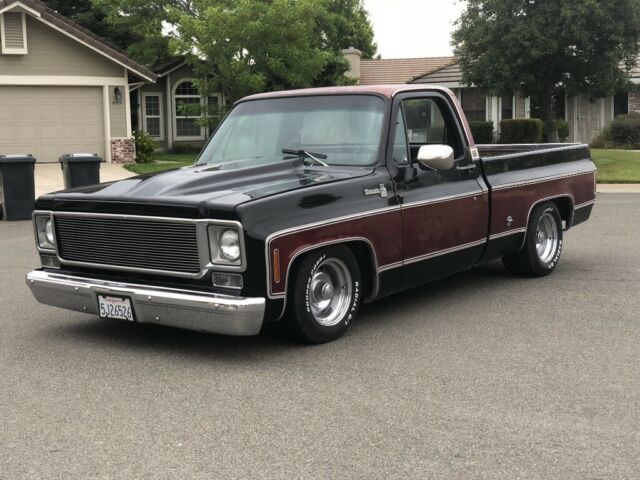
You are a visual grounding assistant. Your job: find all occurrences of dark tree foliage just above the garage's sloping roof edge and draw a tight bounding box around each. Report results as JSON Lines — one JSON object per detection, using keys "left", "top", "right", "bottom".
{"left": 44, "top": 0, "right": 152, "bottom": 58}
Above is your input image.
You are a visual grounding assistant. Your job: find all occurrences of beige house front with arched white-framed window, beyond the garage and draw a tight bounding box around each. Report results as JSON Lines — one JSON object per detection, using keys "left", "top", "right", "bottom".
{"left": 132, "top": 57, "right": 223, "bottom": 150}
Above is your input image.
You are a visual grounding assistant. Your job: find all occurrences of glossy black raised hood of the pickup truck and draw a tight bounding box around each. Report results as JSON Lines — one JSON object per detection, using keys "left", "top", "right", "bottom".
{"left": 38, "top": 160, "right": 373, "bottom": 214}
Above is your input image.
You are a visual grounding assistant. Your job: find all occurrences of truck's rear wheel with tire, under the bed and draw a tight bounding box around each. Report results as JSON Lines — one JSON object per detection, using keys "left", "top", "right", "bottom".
{"left": 502, "top": 202, "right": 562, "bottom": 277}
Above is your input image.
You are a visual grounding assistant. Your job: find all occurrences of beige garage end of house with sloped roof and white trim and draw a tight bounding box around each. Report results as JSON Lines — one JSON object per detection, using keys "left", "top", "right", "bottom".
{"left": 0, "top": 0, "right": 155, "bottom": 162}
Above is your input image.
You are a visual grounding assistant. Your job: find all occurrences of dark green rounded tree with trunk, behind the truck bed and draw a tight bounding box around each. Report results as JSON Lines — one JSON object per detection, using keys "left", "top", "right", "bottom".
{"left": 453, "top": 0, "right": 640, "bottom": 136}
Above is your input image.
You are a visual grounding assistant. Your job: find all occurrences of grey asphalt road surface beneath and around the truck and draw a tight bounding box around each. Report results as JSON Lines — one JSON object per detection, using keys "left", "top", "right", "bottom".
{"left": 0, "top": 195, "right": 640, "bottom": 479}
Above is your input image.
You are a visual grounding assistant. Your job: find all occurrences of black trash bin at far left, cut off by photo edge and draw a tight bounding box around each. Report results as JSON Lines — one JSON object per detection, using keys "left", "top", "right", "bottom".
{"left": 0, "top": 155, "right": 36, "bottom": 220}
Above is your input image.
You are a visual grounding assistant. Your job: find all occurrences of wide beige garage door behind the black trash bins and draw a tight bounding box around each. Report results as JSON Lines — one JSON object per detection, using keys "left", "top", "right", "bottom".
{"left": 0, "top": 86, "right": 104, "bottom": 162}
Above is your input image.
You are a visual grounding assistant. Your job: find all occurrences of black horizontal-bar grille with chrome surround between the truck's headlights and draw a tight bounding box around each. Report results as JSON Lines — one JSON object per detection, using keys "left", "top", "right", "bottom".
{"left": 54, "top": 215, "right": 201, "bottom": 276}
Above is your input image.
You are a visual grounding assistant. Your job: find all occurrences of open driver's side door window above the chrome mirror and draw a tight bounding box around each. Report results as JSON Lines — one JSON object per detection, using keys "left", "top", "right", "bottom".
{"left": 402, "top": 98, "right": 463, "bottom": 160}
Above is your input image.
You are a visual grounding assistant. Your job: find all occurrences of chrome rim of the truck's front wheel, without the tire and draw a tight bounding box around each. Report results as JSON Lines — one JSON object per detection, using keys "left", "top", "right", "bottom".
{"left": 308, "top": 258, "right": 353, "bottom": 327}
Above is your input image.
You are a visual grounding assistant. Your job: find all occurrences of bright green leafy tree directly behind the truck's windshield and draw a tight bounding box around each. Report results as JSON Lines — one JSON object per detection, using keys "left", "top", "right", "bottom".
{"left": 174, "top": 0, "right": 332, "bottom": 101}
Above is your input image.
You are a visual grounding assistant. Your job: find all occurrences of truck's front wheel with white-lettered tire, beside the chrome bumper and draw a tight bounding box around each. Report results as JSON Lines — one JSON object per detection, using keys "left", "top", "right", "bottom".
{"left": 287, "top": 246, "right": 362, "bottom": 343}
